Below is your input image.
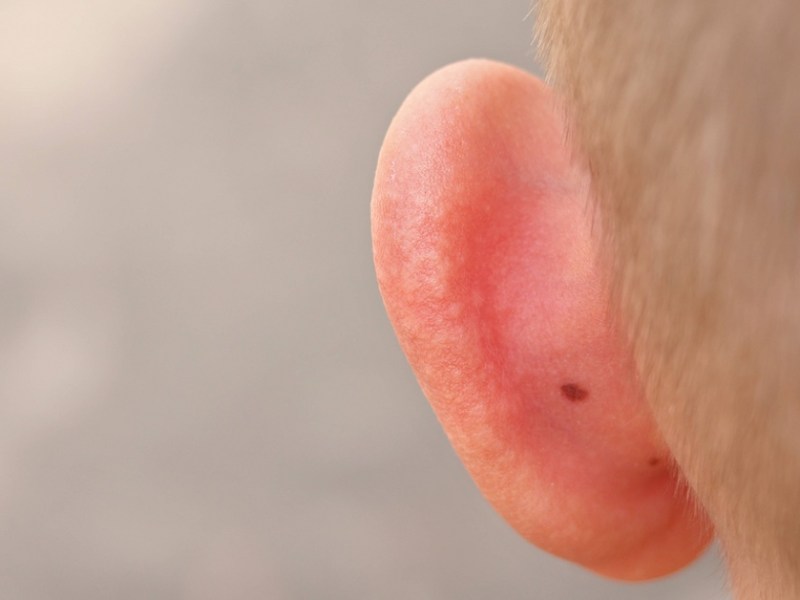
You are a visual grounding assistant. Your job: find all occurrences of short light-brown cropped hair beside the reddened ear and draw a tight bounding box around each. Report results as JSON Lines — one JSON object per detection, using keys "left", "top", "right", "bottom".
{"left": 536, "top": 0, "right": 800, "bottom": 597}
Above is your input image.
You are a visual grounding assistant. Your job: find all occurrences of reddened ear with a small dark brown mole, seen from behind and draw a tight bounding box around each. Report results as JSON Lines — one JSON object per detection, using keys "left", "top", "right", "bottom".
{"left": 372, "top": 61, "right": 711, "bottom": 580}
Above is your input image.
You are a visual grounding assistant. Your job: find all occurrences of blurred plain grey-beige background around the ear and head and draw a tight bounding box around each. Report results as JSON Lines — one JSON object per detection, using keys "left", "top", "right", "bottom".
{"left": 0, "top": 0, "right": 727, "bottom": 600}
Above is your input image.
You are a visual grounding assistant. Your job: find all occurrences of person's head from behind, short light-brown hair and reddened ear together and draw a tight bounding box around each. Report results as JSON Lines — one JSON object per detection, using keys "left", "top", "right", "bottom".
{"left": 373, "top": 0, "right": 800, "bottom": 598}
